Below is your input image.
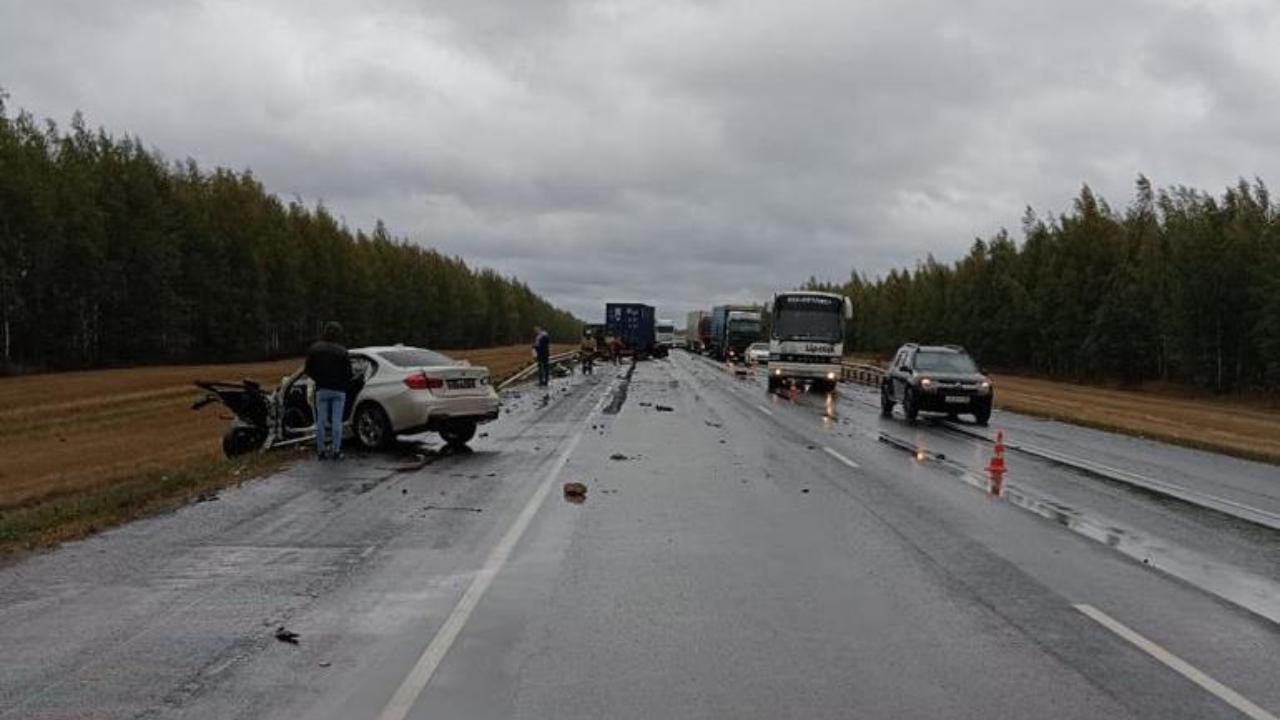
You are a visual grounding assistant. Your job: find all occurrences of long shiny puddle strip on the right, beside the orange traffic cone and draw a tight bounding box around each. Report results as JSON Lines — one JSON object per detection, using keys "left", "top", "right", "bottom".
{"left": 879, "top": 432, "right": 1280, "bottom": 623}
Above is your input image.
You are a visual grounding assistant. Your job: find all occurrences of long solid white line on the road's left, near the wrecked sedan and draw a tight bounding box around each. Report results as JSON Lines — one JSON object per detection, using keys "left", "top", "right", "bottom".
{"left": 378, "top": 380, "right": 617, "bottom": 720}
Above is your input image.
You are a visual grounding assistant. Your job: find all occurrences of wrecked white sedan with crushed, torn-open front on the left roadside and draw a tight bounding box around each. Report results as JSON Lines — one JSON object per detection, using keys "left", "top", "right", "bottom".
{"left": 192, "top": 345, "right": 500, "bottom": 457}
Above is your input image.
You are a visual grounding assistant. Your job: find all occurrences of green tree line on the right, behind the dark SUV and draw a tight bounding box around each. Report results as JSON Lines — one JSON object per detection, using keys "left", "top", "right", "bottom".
{"left": 808, "top": 177, "right": 1280, "bottom": 395}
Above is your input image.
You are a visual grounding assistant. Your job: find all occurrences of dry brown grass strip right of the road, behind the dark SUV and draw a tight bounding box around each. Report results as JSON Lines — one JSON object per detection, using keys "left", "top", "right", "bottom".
{"left": 849, "top": 356, "right": 1280, "bottom": 462}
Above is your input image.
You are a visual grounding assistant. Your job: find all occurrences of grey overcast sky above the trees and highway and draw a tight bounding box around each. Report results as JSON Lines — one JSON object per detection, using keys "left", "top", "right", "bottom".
{"left": 0, "top": 0, "right": 1280, "bottom": 319}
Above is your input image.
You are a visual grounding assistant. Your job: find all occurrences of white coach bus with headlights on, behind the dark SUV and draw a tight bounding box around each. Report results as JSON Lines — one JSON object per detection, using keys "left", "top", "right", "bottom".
{"left": 765, "top": 291, "right": 854, "bottom": 391}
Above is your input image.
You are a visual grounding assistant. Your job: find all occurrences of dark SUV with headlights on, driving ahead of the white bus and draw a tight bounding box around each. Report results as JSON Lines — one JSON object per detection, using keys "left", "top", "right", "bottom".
{"left": 881, "top": 342, "right": 992, "bottom": 425}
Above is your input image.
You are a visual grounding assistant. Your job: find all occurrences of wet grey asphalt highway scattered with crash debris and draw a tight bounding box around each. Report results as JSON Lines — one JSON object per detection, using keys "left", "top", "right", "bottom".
{"left": 0, "top": 354, "right": 1280, "bottom": 720}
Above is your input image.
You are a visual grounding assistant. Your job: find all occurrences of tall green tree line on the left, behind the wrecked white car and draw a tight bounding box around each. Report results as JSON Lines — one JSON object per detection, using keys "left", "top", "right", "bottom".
{"left": 0, "top": 94, "right": 581, "bottom": 372}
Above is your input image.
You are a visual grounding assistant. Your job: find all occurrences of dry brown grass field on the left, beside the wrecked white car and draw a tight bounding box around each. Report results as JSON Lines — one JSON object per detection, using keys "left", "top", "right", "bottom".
{"left": 0, "top": 345, "right": 570, "bottom": 548}
